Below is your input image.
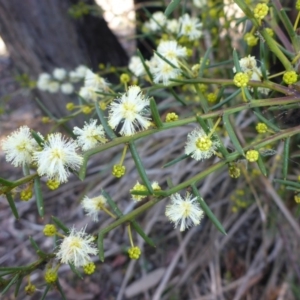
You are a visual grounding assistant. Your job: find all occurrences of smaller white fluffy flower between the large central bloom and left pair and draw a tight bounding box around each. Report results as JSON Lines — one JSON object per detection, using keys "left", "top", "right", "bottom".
{"left": 73, "top": 119, "right": 106, "bottom": 151}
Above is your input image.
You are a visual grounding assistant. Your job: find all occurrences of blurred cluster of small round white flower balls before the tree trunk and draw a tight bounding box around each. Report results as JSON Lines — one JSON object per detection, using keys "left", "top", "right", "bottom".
{"left": 37, "top": 65, "right": 87, "bottom": 95}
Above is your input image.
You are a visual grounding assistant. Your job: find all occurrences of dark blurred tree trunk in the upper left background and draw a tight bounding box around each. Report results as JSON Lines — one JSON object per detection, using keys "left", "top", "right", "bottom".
{"left": 0, "top": 0, "right": 128, "bottom": 122}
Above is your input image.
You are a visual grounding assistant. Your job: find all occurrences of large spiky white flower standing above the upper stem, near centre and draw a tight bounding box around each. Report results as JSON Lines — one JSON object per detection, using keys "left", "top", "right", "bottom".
{"left": 108, "top": 86, "right": 150, "bottom": 135}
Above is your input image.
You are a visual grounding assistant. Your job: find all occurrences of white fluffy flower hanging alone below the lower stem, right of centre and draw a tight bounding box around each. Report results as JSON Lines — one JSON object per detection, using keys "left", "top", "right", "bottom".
{"left": 165, "top": 193, "right": 203, "bottom": 231}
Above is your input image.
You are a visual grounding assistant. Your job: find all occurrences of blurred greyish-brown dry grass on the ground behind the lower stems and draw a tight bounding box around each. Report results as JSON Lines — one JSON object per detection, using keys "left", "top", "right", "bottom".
{"left": 0, "top": 85, "right": 300, "bottom": 300}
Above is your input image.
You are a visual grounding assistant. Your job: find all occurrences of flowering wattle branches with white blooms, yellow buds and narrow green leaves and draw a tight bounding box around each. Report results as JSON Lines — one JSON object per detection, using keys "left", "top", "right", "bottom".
{"left": 0, "top": 0, "right": 300, "bottom": 299}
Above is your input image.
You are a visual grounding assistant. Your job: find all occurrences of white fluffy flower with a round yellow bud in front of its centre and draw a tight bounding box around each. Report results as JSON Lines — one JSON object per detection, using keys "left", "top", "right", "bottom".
{"left": 185, "top": 128, "right": 219, "bottom": 160}
